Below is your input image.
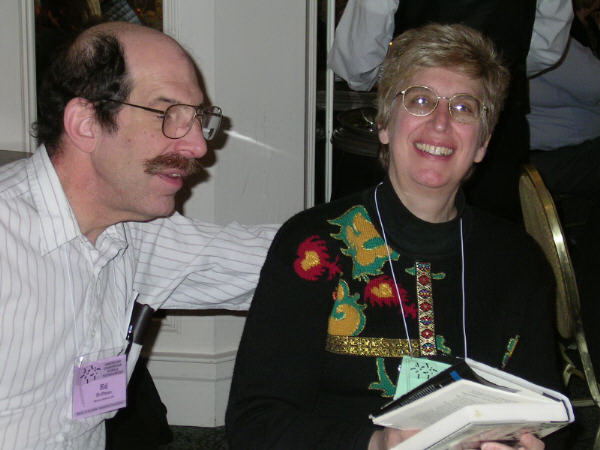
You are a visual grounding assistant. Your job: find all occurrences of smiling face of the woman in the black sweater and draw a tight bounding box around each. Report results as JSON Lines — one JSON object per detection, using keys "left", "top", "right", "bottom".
{"left": 379, "top": 67, "right": 489, "bottom": 193}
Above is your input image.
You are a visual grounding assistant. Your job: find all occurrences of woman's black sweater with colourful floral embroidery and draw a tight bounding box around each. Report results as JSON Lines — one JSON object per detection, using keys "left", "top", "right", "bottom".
{"left": 227, "top": 181, "right": 560, "bottom": 450}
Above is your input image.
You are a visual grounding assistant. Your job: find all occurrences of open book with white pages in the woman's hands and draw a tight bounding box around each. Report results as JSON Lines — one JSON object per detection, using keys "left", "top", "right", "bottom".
{"left": 371, "top": 359, "right": 574, "bottom": 450}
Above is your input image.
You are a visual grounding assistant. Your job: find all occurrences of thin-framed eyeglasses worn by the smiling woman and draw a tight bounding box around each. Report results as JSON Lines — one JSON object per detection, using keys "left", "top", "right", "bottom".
{"left": 396, "top": 86, "right": 487, "bottom": 123}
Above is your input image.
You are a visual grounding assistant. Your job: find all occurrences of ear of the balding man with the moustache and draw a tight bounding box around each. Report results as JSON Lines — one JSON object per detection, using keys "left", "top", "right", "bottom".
{"left": 63, "top": 97, "right": 100, "bottom": 153}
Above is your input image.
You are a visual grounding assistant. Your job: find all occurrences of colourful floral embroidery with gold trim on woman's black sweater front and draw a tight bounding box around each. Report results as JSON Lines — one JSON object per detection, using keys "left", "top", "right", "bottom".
{"left": 293, "top": 205, "right": 466, "bottom": 397}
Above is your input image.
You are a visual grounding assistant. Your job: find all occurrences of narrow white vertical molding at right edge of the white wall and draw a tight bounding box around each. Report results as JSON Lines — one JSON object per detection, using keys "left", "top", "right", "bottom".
{"left": 304, "top": 0, "right": 318, "bottom": 208}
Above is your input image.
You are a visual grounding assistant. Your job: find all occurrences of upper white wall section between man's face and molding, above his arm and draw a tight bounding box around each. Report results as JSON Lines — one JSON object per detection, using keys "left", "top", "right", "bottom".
{"left": 165, "top": 0, "right": 307, "bottom": 223}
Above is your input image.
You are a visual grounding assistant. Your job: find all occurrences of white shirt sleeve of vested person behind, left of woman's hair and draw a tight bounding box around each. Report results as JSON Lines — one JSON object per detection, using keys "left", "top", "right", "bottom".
{"left": 328, "top": 0, "right": 399, "bottom": 91}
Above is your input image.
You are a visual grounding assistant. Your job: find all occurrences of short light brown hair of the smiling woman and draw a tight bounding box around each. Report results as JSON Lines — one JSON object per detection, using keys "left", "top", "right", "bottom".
{"left": 377, "top": 24, "right": 510, "bottom": 167}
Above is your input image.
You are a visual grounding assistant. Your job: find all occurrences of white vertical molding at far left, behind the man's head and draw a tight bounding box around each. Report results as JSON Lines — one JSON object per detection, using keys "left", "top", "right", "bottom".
{"left": 19, "top": 1, "right": 36, "bottom": 152}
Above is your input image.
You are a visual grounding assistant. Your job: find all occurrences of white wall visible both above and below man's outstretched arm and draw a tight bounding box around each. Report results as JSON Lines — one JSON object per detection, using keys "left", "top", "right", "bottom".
{"left": 149, "top": 0, "right": 307, "bottom": 426}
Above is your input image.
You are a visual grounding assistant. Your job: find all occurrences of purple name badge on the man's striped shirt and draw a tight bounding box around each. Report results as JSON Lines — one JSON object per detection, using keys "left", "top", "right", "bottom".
{"left": 73, "top": 355, "right": 127, "bottom": 419}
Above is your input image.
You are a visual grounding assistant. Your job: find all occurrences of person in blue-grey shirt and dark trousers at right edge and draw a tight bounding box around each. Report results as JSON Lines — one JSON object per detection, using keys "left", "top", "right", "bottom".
{"left": 527, "top": 8, "right": 600, "bottom": 202}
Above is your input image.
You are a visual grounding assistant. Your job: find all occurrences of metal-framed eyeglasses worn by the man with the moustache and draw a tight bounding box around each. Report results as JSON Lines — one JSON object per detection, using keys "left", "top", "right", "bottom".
{"left": 103, "top": 98, "right": 223, "bottom": 141}
